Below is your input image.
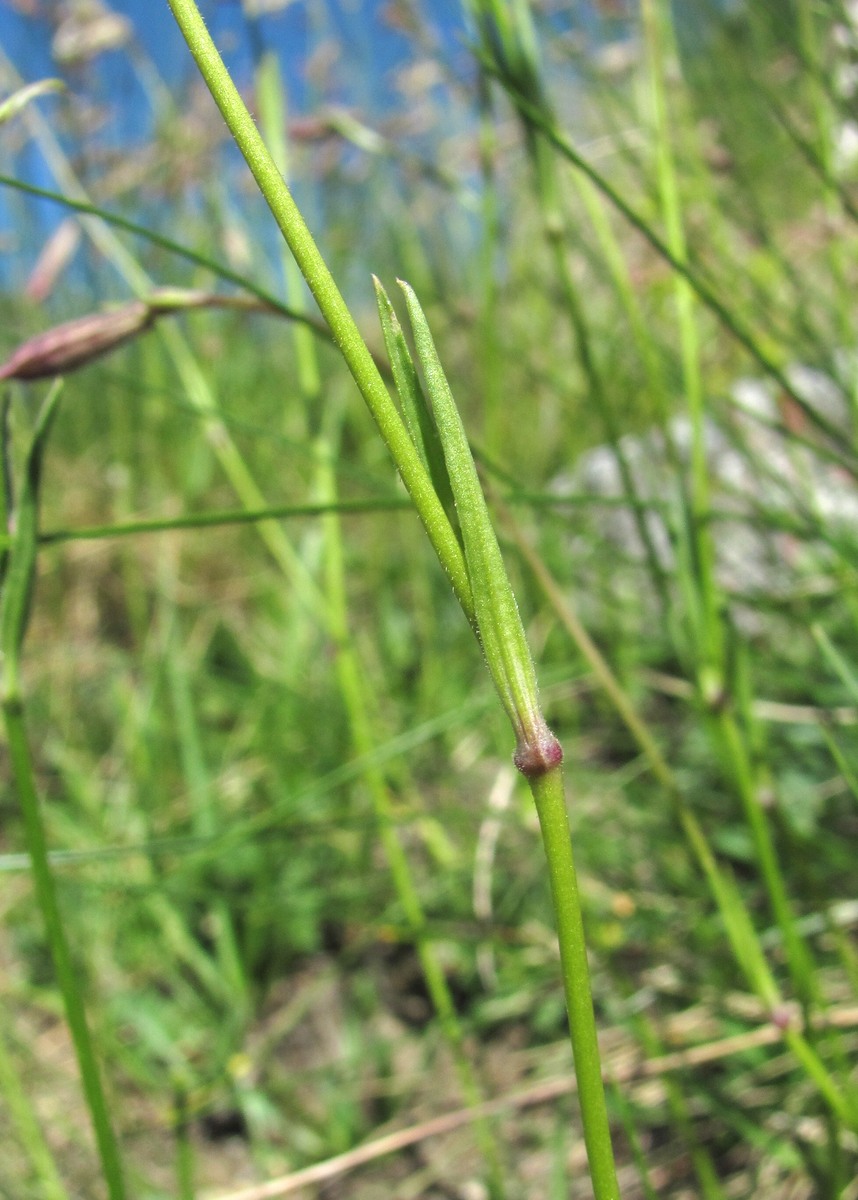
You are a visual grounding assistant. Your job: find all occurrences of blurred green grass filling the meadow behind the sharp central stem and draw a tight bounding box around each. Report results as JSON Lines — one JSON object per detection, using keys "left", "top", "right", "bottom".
{"left": 0, "top": 5, "right": 858, "bottom": 1198}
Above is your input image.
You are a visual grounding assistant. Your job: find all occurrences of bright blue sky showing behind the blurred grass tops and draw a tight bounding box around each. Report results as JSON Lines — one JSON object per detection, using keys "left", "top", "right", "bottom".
{"left": 0, "top": 0, "right": 652, "bottom": 300}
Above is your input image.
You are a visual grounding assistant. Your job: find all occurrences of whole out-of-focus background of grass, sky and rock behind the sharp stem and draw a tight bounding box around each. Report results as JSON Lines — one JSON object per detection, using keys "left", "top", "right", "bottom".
{"left": 0, "top": 0, "right": 858, "bottom": 1200}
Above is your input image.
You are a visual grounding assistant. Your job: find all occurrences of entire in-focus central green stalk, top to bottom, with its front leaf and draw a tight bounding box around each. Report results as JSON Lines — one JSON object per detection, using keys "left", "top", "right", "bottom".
{"left": 169, "top": 7, "right": 619, "bottom": 1200}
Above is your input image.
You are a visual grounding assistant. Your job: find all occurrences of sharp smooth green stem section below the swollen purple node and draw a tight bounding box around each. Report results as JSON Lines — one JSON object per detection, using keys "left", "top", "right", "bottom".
{"left": 528, "top": 767, "right": 619, "bottom": 1200}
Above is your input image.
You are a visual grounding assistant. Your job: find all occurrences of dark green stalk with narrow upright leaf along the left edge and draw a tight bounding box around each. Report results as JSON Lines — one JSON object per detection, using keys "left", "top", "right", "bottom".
{"left": 0, "top": 383, "right": 125, "bottom": 1200}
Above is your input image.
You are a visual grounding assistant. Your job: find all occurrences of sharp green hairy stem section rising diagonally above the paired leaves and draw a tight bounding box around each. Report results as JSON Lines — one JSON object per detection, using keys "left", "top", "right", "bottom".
{"left": 167, "top": 0, "right": 474, "bottom": 624}
